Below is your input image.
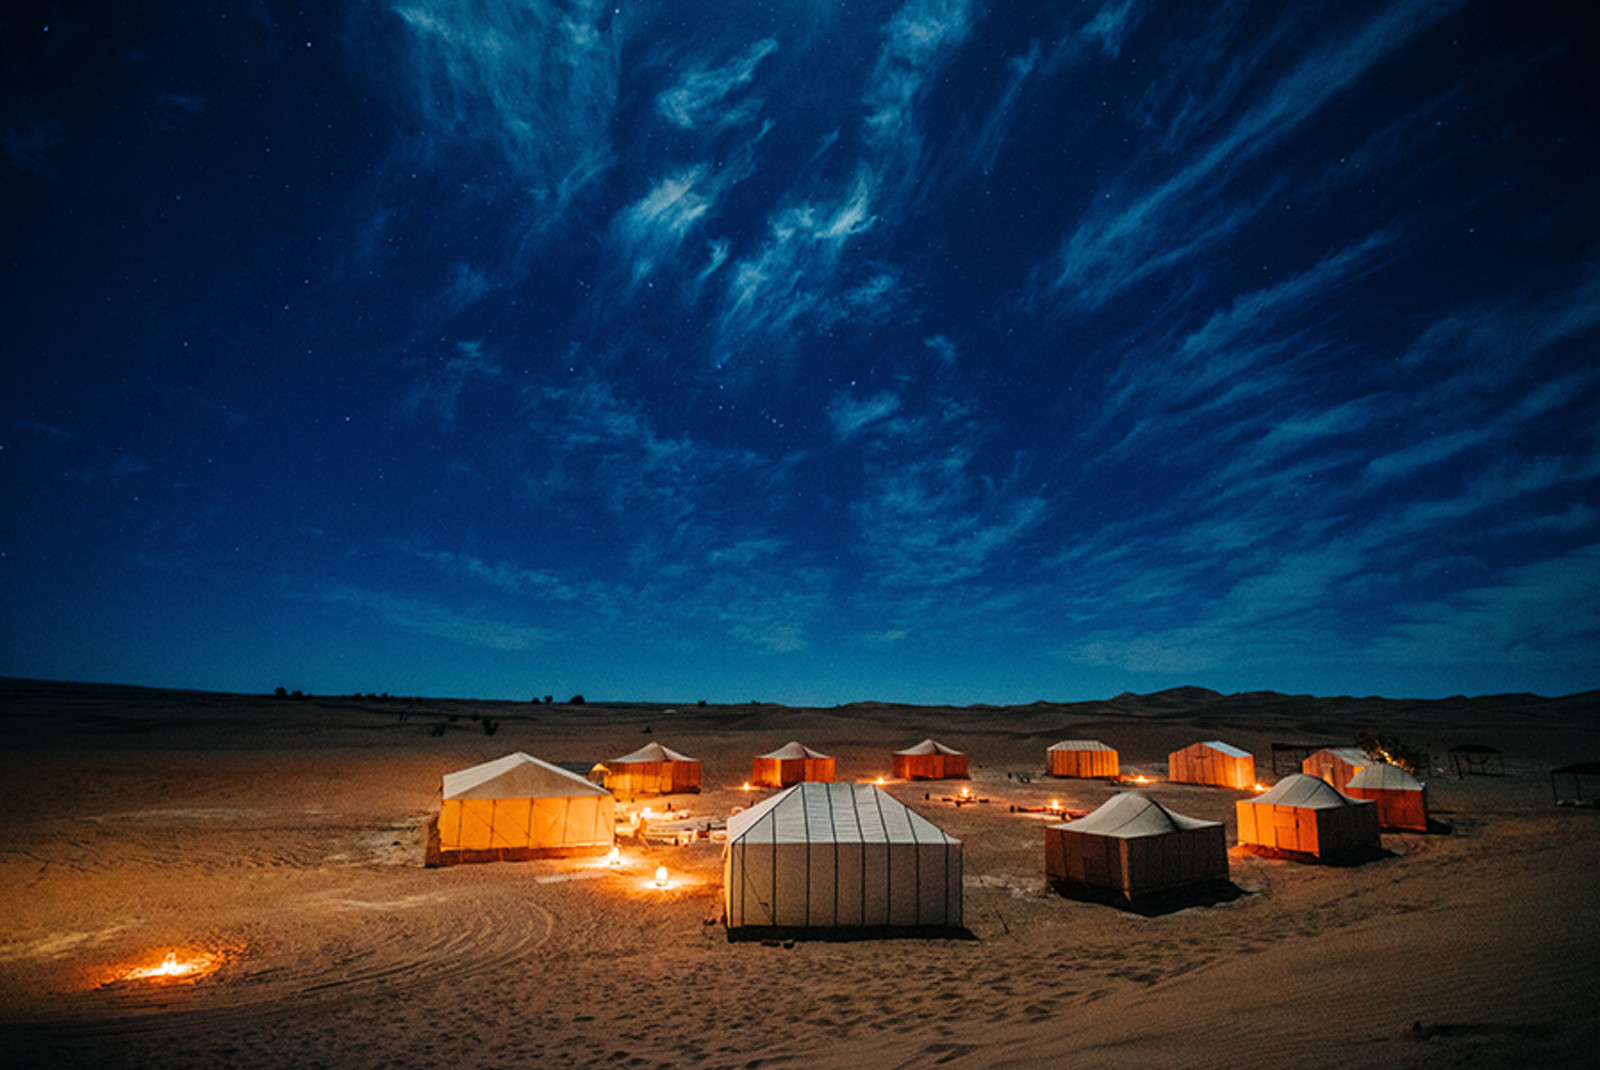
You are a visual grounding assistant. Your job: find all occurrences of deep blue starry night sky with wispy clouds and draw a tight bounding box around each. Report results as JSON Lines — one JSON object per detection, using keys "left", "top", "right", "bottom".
{"left": 0, "top": 0, "right": 1600, "bottom": 704}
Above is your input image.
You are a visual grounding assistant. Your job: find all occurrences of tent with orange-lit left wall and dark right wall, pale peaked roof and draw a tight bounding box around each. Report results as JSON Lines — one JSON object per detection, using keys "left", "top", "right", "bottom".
{"left": 1234, "top": 773, "right": 1381, "bottom": 857}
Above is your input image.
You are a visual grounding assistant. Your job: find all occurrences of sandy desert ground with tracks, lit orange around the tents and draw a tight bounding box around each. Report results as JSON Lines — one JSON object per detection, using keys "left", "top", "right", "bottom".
{"left": 0, "top": 683, "right": 1600, "bottom": 1070}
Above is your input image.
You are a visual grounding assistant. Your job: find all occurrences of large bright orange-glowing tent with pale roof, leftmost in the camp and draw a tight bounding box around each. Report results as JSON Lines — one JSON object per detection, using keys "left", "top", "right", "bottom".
{"left": 429, "top": 752, "right": 616, "bottom": 864}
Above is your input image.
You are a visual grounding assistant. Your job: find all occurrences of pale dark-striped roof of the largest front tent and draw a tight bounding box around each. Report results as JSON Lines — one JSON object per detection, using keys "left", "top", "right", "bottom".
{"left": 728, "top": 782, "right": 960, "bottom": 844}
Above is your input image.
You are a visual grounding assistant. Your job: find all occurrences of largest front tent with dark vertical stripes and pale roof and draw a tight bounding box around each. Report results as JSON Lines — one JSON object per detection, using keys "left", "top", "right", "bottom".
{"left": 723, "top": 784, "right": 962, "bottom": 932}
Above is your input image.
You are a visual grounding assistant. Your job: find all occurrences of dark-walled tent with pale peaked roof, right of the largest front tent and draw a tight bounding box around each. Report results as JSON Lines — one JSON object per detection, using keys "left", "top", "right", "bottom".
{"left": 1045, "top": 792, "right": 1227, "bottom": 900}
